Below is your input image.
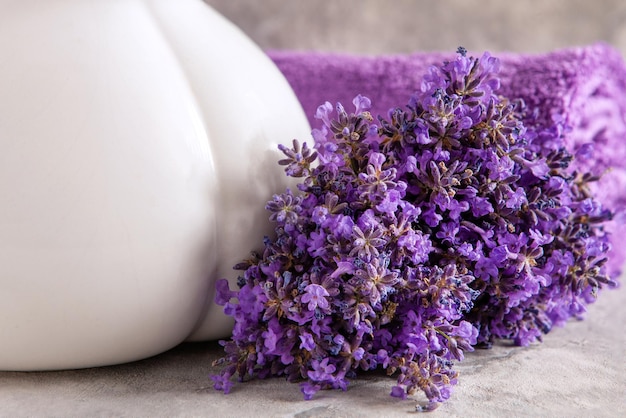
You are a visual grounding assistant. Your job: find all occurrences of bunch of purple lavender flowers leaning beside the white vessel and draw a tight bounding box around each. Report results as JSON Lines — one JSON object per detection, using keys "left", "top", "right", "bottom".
{"left": 213, "top": 48, "right": 616, "bottom": 410}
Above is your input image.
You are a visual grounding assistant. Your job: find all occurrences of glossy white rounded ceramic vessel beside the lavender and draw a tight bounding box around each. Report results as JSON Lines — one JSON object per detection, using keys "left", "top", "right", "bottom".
{"left": 0, "top": 0, "right": 309, "bottom": 370}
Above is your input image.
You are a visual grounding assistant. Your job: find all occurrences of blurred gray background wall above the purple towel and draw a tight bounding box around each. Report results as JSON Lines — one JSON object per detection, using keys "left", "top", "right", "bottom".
{"left": 205, "top": 0, "right": 626, "bottom": 55}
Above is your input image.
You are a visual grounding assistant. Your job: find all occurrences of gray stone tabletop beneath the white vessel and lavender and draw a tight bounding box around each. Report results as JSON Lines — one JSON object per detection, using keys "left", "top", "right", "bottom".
{"left": 0, "top": 287, "right": 626, "bottom": 418}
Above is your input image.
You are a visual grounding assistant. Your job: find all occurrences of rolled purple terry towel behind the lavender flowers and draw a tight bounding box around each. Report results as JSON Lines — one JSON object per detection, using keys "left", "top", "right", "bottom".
{"left": 269, "top": 44, "right": 626, "bottom": 274}
